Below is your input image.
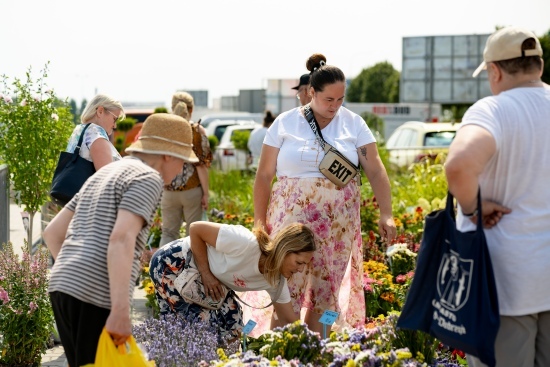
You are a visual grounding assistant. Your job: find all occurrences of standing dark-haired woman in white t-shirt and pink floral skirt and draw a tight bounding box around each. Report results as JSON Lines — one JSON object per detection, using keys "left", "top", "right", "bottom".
{"left": 245, "top": 54, "right": 396, "bottom": 338}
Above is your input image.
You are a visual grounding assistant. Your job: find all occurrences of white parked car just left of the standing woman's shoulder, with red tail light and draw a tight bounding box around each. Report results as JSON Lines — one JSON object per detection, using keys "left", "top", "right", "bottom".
{"left": 214, "top": 123, "right": 262, "bottom": 172}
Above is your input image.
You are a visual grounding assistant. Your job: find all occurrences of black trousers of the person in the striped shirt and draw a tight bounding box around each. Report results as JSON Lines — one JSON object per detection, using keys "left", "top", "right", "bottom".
{"left": 50, "top": 292, "right": 111, "bottom": 367}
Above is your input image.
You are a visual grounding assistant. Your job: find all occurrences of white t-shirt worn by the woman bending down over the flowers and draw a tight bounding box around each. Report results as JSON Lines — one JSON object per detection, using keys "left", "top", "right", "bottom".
{"left": 187, "top": 224, "right": 290, "bottom": 306}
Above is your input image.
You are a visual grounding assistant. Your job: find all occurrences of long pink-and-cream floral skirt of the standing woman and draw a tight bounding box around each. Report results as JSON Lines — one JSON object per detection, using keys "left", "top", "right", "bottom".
{"left": 241, "top": 178, "right": 365, "bottom": 336}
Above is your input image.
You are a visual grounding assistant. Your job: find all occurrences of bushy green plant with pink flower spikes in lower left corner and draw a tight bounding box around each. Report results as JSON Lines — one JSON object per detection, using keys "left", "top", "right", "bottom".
{"left": 0, "top": 242, "right": 54, "bottom": 366}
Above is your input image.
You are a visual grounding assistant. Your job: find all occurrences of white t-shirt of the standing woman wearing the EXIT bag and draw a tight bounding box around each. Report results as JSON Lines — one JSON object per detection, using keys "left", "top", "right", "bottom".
{"left": 264, "top": 107, "right": 376, "bottom": 178}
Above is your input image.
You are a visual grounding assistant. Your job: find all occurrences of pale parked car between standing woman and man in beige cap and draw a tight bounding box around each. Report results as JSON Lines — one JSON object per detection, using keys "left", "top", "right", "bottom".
{"left": 386, "top": 121, "right": 460, "bottom": 167}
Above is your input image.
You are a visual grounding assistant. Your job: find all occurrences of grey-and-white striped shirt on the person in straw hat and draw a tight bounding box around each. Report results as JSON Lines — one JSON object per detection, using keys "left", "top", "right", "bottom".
{"left": 48, "top": 156, "right": 164, "bottom": 309}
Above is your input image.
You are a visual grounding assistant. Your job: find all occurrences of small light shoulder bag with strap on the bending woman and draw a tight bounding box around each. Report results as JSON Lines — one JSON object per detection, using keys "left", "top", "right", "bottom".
{"left": 174, "top": 250, "right": 284, "bottom": 310}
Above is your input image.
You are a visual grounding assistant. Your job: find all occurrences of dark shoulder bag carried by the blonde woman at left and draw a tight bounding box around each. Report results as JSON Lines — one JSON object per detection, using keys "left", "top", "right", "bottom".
{"left": 50, "top": 124, "right": 95, "bottom": 206}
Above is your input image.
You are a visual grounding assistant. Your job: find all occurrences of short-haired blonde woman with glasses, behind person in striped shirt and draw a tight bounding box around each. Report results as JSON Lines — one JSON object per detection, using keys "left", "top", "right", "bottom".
{"left": 66, "top": 94, "right": 125, "bottom": 171}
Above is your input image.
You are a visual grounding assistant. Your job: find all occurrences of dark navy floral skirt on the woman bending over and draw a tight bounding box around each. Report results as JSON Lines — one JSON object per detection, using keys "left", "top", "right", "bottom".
{"left": 149, "top": 239, "right": 243, "bottom": 344}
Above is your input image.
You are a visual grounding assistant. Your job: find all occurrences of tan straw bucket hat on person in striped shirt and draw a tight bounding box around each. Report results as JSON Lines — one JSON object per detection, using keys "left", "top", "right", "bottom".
{"left": 126, "top": 113, "right": 199, "bottom": 163}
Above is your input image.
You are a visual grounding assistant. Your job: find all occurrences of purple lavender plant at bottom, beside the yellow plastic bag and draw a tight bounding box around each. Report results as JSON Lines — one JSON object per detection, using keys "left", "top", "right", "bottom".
{"left": 133, "top": 314, "right": 226, "bottom": 367}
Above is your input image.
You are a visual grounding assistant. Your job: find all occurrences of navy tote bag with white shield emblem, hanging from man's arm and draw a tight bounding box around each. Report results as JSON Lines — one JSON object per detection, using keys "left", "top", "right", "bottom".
{"left": 397, "top": 192, "right": 500, "bottom": 367}
